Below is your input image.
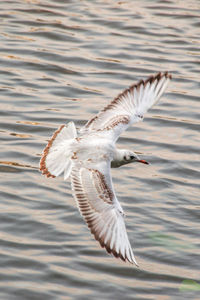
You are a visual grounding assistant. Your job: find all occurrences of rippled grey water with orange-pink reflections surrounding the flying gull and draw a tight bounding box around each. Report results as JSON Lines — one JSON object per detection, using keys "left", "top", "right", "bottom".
{"left": 0, "top": 0, "right": 200, "bottom": 300}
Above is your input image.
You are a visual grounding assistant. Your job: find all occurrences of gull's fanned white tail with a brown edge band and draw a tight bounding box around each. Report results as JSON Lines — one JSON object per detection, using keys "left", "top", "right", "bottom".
{"left": 40, "top": 122, "right": 77, "bottom": 179}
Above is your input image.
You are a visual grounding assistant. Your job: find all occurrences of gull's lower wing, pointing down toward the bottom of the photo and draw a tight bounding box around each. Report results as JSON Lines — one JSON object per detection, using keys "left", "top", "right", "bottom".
{"left": 71, "top": 162, "right": 137, "bottom": 265}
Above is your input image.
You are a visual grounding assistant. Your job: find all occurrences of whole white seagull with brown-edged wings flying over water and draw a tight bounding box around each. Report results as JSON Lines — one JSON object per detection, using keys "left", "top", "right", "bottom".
{"left": 40, "top": 72, "right": 172, "bottom": 266}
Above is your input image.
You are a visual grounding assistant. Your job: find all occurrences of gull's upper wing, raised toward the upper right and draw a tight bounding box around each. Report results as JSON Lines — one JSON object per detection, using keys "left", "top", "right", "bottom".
{"left": 82, "top": 72, "right": 171, "bottom": 141}
